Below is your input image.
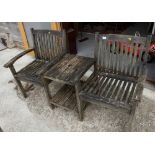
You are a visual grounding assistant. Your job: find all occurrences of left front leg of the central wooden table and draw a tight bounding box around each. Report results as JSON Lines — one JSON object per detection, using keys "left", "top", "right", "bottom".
{"left": 42, "top": 78, "right": 55, "bottom": 109}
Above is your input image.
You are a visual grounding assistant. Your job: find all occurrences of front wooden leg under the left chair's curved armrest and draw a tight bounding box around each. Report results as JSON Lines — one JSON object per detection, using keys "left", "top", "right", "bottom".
{"left": 10, "top": 66, "right": 27, "bottom": 98}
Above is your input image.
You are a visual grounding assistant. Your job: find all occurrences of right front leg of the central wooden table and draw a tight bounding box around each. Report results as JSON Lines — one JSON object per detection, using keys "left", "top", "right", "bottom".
{"left": 75, "top": 82, "right": 83, "bottom": 121}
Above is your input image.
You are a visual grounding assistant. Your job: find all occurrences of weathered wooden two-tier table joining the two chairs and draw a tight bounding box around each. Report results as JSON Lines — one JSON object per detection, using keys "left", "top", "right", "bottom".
{"left": 43, "top": 54, "right": 94, "bottom": 120}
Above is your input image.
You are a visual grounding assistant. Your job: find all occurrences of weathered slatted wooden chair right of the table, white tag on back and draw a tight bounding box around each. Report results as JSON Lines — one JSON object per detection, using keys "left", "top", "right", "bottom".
{"left": 80, "top": 34, "right": 150, "bottom": 130}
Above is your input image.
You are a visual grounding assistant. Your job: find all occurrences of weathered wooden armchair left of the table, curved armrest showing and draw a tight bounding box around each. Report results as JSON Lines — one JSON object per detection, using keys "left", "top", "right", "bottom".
{"left": 4, "top": 29, "right": 66, "bottom": 97}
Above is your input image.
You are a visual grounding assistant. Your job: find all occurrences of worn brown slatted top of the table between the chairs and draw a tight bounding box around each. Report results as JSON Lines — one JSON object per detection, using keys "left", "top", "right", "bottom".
{"left": 44, "top": 54, "right": 94, "bottom": 85}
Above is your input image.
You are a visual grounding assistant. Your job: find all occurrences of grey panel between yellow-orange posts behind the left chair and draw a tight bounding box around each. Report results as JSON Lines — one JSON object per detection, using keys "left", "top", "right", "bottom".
{"left": 23, "top": 22, "right": 51, "bottom": 47}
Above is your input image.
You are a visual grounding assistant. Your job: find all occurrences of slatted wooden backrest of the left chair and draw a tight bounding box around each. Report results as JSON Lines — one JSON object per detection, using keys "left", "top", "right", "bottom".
{"left": 31, "top": 29, "right": 66, "bottom": 61}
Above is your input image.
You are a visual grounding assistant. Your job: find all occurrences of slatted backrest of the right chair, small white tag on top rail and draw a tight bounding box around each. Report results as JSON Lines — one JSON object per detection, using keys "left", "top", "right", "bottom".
{"left": 94, "top": 33, "right": 151, "bottom": 77}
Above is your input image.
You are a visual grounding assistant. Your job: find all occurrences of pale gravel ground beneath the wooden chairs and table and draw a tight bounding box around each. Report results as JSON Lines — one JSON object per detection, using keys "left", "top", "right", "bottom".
{"left": 0, "top": 49, "right": 155, "bottom": 132}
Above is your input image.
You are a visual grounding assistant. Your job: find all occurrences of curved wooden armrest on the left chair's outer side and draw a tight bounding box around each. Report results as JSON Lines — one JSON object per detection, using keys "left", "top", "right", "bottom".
{"left": 4, "top": 48, "right": 34, "bottom": 68}
